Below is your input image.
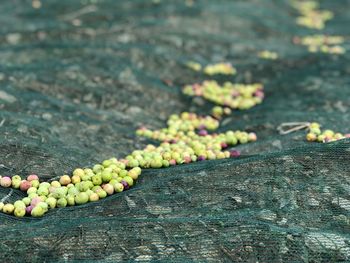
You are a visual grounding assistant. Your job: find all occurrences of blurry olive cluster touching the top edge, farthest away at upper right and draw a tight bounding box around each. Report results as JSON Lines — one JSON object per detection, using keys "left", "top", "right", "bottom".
{"left": 293, "top": 1, "right": 334, "bottom": 30}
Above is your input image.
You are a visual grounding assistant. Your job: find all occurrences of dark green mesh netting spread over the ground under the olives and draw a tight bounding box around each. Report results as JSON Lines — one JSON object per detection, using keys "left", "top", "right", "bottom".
{"left": 0, "top": 0, "right": 350, "bottom": 262}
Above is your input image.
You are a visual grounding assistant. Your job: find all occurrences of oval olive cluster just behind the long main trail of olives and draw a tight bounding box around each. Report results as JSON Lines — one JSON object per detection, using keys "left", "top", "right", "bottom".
{"left": 183, "top": 80, "right": 264, "bottom": 110}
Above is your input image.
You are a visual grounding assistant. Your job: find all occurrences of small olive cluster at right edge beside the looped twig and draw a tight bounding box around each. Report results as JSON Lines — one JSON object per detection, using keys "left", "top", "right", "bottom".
{"left": 306, "top": 122, "right": 350, "bottom": 142}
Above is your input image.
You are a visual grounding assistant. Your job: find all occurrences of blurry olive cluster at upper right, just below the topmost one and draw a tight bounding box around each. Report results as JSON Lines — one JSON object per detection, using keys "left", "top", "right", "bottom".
{"left": 293, "top": 35, "right": 345, "bottom": 54}
